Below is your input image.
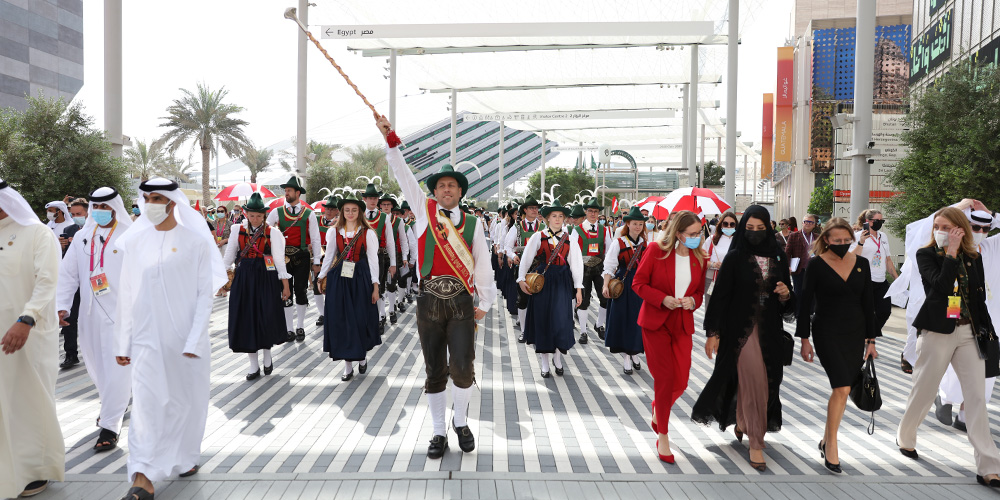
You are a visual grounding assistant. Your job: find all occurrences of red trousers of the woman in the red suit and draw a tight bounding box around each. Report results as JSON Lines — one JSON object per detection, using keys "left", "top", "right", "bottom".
{"left": 642, "top": 328, "right": 692, "bottom": 434}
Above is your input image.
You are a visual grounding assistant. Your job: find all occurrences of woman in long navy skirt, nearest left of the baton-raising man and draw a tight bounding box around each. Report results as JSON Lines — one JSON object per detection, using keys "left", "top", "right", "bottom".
{"left": 318, "top": 193, "right": 382, "bottom": 382}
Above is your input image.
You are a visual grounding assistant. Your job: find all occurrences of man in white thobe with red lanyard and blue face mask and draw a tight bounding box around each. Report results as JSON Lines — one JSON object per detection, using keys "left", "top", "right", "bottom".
{"left": 56, "top": 187, "right": 132, "bottom": 452}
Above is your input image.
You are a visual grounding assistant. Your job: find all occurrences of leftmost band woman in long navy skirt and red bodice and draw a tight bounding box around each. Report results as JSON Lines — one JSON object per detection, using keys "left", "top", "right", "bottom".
{"left": 219, "top": 193, "right": 292, "bottom": 380}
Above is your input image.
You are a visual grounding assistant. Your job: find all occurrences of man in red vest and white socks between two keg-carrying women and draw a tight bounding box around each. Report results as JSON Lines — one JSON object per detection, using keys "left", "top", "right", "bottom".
{"left": 576, "top": 197, "right": 614, "bottom": 344}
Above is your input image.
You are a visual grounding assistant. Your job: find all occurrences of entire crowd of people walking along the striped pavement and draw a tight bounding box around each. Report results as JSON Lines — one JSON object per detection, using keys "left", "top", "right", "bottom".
{"left": 0, "top": 114, "right": 1000, "bottom": 500}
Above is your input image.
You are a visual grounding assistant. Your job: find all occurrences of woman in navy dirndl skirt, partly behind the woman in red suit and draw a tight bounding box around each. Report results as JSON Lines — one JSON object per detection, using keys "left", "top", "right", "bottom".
{"left": 601, "top": 207, "right": 647, "bottom": 375}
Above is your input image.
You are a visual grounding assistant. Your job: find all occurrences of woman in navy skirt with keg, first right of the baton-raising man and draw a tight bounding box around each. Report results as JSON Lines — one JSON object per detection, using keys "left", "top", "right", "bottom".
{"left": 517, "top": 200, "right": 583, "bottom": 378}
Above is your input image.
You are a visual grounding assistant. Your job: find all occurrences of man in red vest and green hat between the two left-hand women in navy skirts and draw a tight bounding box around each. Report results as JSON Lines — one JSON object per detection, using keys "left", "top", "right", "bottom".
{"left": 267, "top": 176, "right": 323, "bottom": 342}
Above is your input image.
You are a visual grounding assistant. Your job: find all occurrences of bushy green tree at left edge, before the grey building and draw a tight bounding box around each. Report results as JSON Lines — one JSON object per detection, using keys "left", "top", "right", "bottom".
{"left": 0, "top": 95, "right": 134, "bottom": 214}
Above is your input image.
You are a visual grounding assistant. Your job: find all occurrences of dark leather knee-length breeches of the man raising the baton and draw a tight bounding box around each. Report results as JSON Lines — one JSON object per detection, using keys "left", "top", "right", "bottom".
{"left": 417, "top": 288, "right": 476, "bottom": 394}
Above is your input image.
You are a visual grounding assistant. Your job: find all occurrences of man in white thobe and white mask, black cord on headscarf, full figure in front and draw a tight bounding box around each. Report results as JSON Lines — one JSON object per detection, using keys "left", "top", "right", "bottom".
{"left": 115, "top": 178, "right": 226, "bottom": 500}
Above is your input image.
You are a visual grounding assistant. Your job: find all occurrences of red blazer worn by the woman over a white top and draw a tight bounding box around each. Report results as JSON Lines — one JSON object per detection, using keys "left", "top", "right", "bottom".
{"left": 632, "top": 242, "right": 705, "bottom": 335}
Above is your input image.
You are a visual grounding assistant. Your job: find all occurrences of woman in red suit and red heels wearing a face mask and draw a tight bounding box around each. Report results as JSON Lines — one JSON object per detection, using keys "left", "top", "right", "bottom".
{"left": 632, "top": 212, "right": 705, "bottom": 464}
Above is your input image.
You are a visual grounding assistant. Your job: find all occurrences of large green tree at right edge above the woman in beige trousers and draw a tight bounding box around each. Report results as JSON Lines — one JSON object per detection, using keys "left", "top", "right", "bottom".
{"left": 886, "top": 62, "right": 1000, "bottom": 233}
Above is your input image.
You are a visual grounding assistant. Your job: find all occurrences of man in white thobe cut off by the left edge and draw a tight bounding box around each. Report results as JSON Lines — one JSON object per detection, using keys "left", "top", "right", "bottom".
{"left": 0, "top": 180, "right": 65, "bottom": 498}
